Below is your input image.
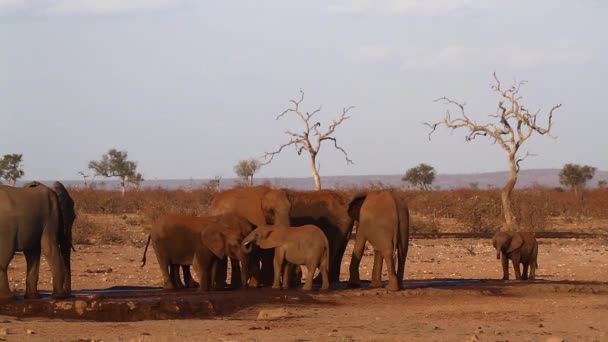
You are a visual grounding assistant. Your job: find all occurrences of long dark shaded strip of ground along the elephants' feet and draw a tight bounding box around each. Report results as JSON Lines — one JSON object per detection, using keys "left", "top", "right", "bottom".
{"left": 0, "top": 279, "right": 608, "bottom": 322}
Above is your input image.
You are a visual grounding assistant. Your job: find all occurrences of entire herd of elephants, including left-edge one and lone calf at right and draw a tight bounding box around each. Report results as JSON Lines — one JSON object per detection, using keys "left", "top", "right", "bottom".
{"left": 0, "top": 182, "right": 538, "bottom": 299}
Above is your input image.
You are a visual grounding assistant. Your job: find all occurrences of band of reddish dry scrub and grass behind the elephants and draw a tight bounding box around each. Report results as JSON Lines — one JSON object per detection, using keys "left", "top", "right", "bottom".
{"left": 70, "top": 183, "right": 608, "bottom": 245}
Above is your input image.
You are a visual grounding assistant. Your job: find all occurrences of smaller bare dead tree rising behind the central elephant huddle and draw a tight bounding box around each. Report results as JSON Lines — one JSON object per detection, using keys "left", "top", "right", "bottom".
{"left": 262, "top": 90, "right": 354, "bottom": 190}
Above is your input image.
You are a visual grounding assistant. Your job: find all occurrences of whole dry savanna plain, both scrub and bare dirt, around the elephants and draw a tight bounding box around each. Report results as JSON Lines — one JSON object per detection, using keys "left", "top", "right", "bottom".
{"left": 0, "top": 189, "right": 608, "bottom": 341}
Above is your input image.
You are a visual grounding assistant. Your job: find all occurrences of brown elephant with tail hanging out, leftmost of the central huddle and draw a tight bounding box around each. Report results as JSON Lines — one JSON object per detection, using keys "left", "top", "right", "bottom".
{"left": 142, "top": 214, "right": 253, "bottom": 289}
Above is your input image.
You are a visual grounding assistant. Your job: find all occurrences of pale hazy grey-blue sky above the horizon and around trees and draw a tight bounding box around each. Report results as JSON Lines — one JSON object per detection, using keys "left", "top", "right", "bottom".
{"left": 0, "top": 0, "right": 608, "bottom": 179}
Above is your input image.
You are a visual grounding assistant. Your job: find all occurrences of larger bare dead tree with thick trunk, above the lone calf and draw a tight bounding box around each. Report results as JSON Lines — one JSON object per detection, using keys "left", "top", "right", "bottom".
{"left": 425, "top": 73, "right": 561, "bottom": 230}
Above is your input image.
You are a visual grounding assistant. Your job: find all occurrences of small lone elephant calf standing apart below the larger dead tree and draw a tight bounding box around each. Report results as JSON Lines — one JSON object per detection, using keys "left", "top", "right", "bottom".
{"left": 492, "top": 231, "right": 538, "bottom": 280}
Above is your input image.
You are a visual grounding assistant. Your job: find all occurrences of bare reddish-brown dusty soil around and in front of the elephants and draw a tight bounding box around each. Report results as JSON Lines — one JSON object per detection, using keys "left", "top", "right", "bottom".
{"left": 0, "top": 215, "right": 608, "bottom": 341}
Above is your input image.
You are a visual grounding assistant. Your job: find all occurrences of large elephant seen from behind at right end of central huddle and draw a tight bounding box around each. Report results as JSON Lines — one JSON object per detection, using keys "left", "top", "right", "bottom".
{"left": 349, "top": 191, "right": 409, "bottom": 291}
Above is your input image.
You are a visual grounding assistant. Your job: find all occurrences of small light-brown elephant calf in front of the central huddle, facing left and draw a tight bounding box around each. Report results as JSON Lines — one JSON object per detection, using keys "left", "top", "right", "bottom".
{"left": 243, "top": 224, "right": 329, "bottom": 290}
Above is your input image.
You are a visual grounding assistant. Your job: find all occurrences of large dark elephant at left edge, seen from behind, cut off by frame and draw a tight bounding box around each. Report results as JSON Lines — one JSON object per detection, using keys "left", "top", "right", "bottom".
{"left": 0, "top": 182, "right": 76, "bottom": 298}
